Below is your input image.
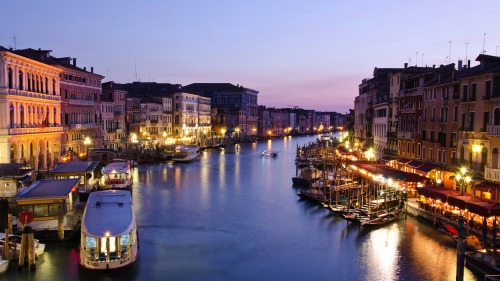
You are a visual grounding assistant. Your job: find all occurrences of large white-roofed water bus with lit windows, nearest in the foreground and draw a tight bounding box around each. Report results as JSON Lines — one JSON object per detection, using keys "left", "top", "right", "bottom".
{"left": 80, "top": 190, "right": 139, "bottom": 270}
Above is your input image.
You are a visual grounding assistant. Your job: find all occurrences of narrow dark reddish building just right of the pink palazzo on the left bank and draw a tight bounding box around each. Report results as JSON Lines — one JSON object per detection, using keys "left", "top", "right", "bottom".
{"left": 101, "top": 81, "right": 127, "bottom": 149}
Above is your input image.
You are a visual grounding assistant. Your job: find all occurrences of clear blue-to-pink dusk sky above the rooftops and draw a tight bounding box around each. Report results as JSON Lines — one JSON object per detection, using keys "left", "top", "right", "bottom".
{"left": 0, "top": 0, "right": 500, "bottom": 113}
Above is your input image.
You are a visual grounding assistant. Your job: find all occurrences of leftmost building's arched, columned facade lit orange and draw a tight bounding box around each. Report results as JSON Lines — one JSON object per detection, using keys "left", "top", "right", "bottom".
{"left": 0, "top": 47, "right": 63, "bottom": 169}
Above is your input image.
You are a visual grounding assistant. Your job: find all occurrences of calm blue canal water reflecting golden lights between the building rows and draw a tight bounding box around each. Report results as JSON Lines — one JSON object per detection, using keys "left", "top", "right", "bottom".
{"left": 0, "top": 136, "right": 480, "bottom": 281}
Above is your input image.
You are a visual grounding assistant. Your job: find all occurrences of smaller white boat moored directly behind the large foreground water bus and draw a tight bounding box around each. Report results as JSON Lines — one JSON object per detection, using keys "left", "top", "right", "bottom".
{"left": 100, "top": 162, "right": 132, "bottom": 189}
